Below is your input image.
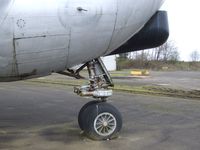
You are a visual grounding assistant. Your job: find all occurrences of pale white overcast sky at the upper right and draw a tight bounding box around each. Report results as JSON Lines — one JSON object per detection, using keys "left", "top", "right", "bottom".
{"left": 161, "top": 0, "right": 200, "bottom": 61}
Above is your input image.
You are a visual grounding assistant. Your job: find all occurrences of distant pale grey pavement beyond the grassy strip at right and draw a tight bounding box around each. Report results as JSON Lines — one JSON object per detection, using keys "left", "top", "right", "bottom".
{"left": 114, "top": 71, "right": 200, "bottom": 91}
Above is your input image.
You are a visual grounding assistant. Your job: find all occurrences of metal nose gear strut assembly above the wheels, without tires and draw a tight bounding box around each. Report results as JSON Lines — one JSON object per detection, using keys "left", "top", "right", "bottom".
{"left": 74, "top": 58, "right": 114, "bottom": 101}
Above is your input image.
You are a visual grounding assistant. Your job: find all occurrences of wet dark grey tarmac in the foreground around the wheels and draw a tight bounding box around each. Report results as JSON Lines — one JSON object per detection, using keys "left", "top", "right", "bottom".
{"left": 0, "top": 75, "right": 200, "bottom": 150}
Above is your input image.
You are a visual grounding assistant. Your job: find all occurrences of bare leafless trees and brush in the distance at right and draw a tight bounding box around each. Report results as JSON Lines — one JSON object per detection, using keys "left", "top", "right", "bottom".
{"left": 117, "top": 41, "right": 200, "bottom": 69}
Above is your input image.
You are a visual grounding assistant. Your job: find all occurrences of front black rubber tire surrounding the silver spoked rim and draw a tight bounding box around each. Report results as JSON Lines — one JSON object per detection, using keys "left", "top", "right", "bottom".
{"left": 83, "top": 102, "right": 122, "bottom": 140}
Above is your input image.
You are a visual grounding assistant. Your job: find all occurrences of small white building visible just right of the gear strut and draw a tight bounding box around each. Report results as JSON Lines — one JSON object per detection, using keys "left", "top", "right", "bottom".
{"left": 102, "top": 55, "right": 117, "bottom": 71}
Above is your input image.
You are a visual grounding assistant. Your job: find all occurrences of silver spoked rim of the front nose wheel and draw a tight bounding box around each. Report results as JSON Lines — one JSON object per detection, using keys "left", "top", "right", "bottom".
{"left": 94, "top": 113, "right": 117, "bottom": 137}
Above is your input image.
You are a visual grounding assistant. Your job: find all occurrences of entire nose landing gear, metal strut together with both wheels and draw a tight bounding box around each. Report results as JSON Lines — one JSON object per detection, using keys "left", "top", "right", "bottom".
{"left": 62, "top": 58, "right": 122, "bottom": 140}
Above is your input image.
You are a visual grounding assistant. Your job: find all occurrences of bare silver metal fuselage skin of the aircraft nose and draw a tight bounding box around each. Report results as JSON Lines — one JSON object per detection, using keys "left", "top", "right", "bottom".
{"left": 0, "top": 0, "right": 163, "bottom": 81}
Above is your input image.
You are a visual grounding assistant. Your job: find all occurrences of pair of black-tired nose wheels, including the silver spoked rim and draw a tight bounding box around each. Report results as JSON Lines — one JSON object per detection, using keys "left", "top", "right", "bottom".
{"left": 78, "top": 101, "right": 122, "bottom": 140}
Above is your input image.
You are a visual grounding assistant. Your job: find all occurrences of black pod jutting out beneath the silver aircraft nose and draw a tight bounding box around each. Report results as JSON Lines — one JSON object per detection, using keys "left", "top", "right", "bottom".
{"left": 110, "top": 11, "right": 169, "bottom": 55}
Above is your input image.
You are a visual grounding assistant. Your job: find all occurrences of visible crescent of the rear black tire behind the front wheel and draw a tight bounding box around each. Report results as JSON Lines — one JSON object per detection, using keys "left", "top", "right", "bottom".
{"left": 78, "top": 101, "right": 99, "bottom": 130}
